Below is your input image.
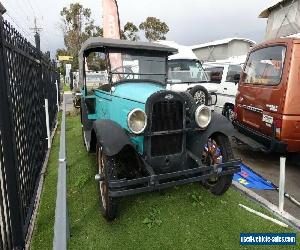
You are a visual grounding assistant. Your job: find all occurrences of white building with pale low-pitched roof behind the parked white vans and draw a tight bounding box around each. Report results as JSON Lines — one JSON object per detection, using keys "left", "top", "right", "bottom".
{"left": 190, "top": 37, "right": 255, "bottom": 62}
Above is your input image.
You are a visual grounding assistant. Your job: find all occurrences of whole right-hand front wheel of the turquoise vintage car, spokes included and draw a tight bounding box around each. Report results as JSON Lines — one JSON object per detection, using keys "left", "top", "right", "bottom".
{"left": 202, "top": 134, "right": 234, "bottom": 195}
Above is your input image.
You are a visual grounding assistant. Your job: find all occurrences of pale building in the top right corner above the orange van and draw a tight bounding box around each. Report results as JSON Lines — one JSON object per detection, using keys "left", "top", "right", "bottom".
{"left": 259, "top": 0, "right": 300, "bottom": 40}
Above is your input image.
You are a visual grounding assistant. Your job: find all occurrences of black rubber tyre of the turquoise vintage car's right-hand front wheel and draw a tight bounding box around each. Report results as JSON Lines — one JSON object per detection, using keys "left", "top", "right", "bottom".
{"left": 203, "top": 134, "right": 234, "bottom": 195}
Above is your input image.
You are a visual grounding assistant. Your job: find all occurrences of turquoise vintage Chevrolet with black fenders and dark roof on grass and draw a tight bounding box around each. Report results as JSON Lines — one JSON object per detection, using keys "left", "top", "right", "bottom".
{"left": 79, "top": 38, "right": 240, "bottom": 220}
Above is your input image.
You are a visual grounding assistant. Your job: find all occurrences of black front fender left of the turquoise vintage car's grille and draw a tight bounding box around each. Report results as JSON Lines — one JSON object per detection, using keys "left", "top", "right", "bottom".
{"left": 93, "top": 120, "right": 133, "bottom": 156}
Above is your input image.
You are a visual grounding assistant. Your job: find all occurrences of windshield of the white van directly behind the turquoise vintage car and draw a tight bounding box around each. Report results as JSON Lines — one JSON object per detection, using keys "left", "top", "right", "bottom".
{"left": 168, "top": 60, "right": 209, "bottom": 83}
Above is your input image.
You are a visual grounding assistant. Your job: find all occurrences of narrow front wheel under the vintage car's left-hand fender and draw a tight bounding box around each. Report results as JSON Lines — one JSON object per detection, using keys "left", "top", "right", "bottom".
{"left": 96, "top": 143, "right": 118, "bottom": 221}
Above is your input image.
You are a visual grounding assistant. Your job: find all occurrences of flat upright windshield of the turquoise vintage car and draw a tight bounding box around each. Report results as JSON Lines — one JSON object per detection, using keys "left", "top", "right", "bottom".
{"left": 109, "top": 51, "right": 167, "bottom": 83}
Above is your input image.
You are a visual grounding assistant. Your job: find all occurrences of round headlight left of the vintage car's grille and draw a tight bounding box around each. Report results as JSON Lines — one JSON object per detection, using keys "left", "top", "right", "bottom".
{"left": 127, "top": 109, "right": 147, "bottom": 134}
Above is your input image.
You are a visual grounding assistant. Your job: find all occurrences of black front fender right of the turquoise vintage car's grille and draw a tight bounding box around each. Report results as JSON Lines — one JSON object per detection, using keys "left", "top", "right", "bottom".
{"left": 187, "top": 112, "right": 234, "bottom": 156}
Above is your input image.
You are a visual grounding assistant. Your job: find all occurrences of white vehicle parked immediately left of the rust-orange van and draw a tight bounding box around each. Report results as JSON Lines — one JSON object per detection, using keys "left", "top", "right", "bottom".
{"left": 203, "top": 62, "right": 242, "bottom": 121}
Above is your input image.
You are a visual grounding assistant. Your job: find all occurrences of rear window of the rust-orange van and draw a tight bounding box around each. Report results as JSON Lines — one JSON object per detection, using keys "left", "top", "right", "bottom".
{"left": 243, "top": 46, "right": 286, "bottom": 85}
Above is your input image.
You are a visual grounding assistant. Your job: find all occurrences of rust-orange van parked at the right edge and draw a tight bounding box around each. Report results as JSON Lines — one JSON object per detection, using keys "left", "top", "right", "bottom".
{"left": 234, "top": 38, "right": 300, "bottom": 152}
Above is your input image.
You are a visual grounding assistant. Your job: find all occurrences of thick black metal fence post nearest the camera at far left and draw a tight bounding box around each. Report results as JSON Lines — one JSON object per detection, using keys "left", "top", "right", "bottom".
{"left": 0, "top": 3, "right": 24, "bottom": 249}
